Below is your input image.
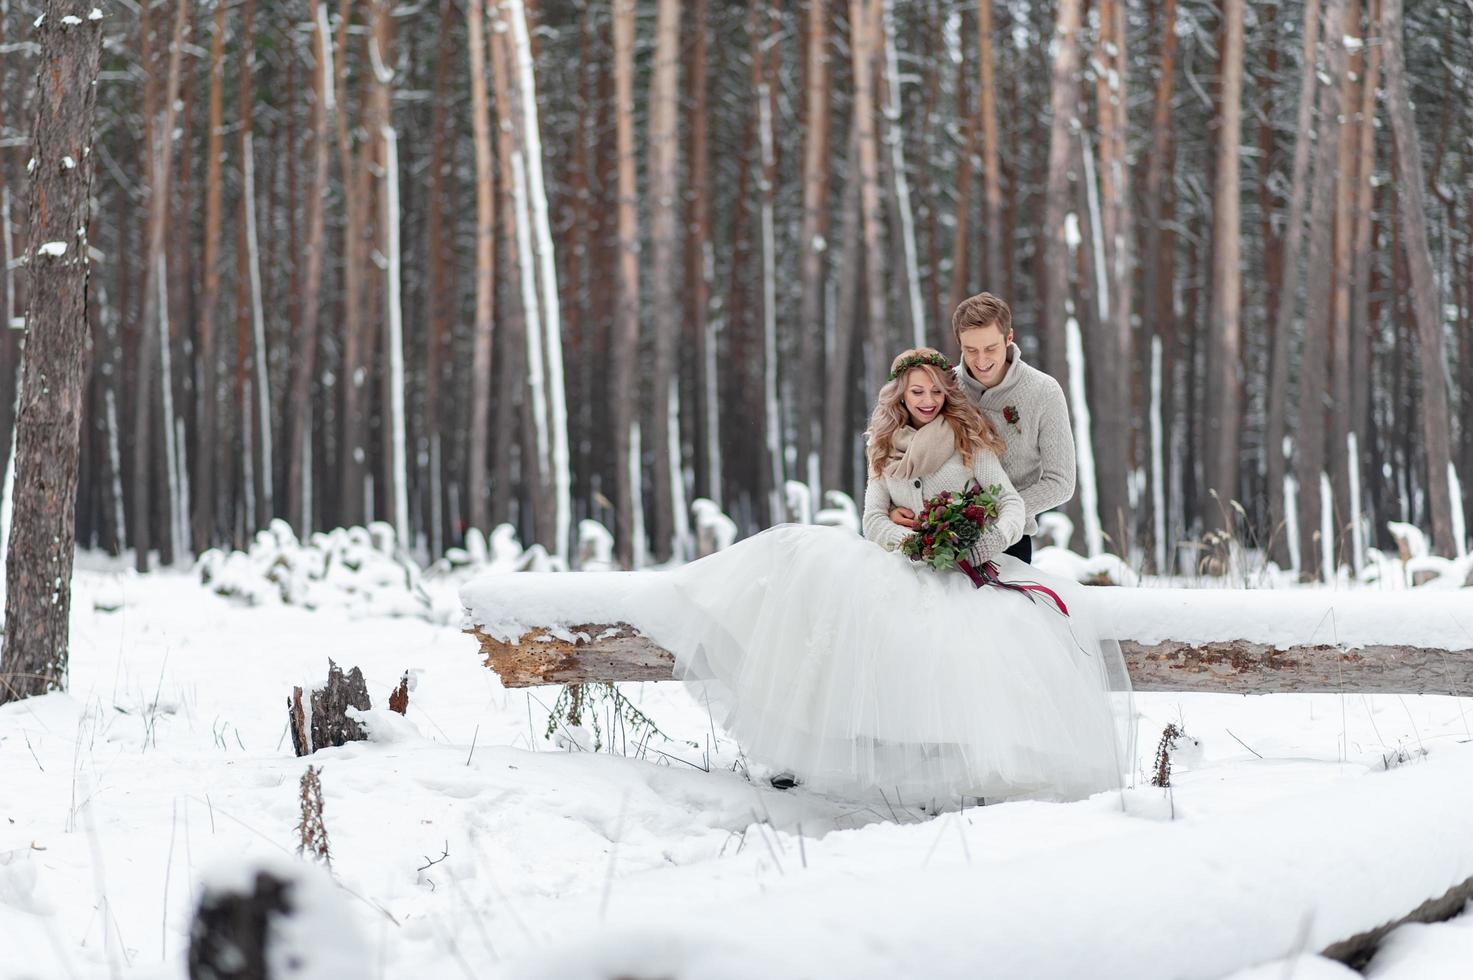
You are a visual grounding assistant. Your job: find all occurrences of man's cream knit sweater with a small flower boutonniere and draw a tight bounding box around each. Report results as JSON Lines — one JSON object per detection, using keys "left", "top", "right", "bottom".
{"left": 953, "top": 343, "right": 1075, "bottom": 535}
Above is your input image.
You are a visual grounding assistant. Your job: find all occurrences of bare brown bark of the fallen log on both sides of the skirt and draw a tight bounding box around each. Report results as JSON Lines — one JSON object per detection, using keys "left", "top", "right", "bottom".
{"left": 465, "top": 623, "right": 1473, "bottom": 697}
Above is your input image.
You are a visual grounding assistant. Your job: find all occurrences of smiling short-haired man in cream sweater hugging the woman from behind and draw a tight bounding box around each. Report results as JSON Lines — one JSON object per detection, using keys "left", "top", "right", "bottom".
{"left": 890, "top": 293, "right": 1074, "bottom": 563}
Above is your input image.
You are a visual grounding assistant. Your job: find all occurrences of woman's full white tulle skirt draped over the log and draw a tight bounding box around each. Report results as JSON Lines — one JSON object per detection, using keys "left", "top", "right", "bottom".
{"left": 654, "top": 525, "right": 1134, "bottom": 803}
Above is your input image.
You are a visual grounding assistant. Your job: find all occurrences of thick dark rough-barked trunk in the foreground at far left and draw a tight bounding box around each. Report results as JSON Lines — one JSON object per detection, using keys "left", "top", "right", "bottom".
{"left": 0, "top": 0, "right": 102, "bottom": 704}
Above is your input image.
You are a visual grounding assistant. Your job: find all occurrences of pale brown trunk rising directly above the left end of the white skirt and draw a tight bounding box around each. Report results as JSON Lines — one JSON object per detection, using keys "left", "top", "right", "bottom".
{"left": 647, "top": 0, "right": 681, "bottom": 563}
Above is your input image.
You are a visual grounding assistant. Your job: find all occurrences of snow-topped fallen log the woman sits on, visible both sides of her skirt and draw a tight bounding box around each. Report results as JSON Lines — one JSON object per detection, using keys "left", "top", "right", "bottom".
{"left": 461, "top": 572, "right": 1473, "bottom": 696}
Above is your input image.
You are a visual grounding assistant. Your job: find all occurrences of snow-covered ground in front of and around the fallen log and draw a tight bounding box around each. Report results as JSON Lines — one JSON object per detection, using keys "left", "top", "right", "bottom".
{"left": 0, "top": 561, "right": 1473, "bottom": 980}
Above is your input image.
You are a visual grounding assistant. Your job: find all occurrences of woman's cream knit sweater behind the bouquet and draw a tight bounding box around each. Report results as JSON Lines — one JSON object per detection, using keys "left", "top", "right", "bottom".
{"left": 865, "top": 449, "right": 1024, "bottom": 564}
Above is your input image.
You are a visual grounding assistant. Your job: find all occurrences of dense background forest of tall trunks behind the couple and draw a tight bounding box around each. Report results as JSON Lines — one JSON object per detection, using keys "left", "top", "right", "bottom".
{"left": 0, "top": 0, "right": 1473, "bottom": 576}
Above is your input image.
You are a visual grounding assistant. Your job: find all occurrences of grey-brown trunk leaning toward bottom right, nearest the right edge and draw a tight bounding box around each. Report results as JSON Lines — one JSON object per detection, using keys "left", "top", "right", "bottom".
{"left": 1378, "top": 0, "right": 1457, "bottom": 557}
